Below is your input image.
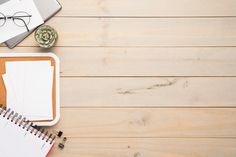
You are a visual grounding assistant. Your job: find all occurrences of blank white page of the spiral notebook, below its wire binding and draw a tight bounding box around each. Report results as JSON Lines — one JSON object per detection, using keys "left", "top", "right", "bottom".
{"left": 0, "top": 109, "right": 54, "bottom": 157}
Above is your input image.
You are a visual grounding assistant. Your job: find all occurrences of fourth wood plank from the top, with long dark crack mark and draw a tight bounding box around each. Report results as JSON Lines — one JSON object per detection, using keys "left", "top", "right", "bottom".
{"left": 61, "top": 77, "right": 236, "bottom": 107}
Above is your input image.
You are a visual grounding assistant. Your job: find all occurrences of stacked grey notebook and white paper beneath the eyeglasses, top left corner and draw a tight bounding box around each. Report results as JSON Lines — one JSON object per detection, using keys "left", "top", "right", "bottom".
{"left": 0, "top": 0, "right": 61, "bottom": 48}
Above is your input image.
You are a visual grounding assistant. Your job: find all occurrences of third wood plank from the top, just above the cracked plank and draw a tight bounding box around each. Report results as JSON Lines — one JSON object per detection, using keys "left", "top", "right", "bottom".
{"left": 0, "top": 47, "right": 236, "bottom": 76}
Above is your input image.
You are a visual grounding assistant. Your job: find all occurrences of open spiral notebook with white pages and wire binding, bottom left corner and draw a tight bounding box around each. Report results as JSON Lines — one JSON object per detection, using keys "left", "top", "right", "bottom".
{"left": 0, "top": 108, "right": 55, "bottom": 157}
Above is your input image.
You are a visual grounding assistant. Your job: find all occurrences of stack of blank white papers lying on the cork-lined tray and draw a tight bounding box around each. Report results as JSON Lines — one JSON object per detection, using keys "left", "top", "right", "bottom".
{"left": 2, "top": 61, "right": 54, "bottom": 121}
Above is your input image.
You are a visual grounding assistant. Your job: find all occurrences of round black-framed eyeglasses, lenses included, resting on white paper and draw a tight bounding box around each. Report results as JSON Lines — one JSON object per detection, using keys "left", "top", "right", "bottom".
{"left": 0, "top": 11, "right": 32, "bottom": 32}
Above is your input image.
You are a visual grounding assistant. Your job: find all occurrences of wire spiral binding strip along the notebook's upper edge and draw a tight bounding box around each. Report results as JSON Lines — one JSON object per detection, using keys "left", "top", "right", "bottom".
{"left": 0, "top": 108, "right": 56, "bottom": 144}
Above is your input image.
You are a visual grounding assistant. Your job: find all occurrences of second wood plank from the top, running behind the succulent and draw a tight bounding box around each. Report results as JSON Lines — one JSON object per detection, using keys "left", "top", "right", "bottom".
{"left": 13, "top": 17, "right": 236, "bottom": 46}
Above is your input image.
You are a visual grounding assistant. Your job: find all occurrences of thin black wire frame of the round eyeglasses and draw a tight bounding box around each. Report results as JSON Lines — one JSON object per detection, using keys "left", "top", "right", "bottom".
{"left": 0, "top": 11, "right": 32, "bottom": 32}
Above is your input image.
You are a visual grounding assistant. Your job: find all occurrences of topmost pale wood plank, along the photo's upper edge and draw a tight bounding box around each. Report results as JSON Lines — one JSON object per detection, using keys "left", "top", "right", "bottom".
{"left": 59, "top": 0, "right": 236, "bottom": 17}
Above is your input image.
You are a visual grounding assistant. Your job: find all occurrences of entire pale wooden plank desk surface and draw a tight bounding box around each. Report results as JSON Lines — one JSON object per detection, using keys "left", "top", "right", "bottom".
{"left": 0, "top": 0, "right": 236, "bottom": 157}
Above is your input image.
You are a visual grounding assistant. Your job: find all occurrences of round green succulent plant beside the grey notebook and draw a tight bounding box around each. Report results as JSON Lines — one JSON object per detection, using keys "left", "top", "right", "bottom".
{"left": 35, "top": 25, "right": 58, "bottom": 48}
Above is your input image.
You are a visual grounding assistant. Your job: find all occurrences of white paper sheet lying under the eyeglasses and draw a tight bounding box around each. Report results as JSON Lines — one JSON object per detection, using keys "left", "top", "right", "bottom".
{"left": 0, "top": 0, "right": 44, "bottom": 43}
